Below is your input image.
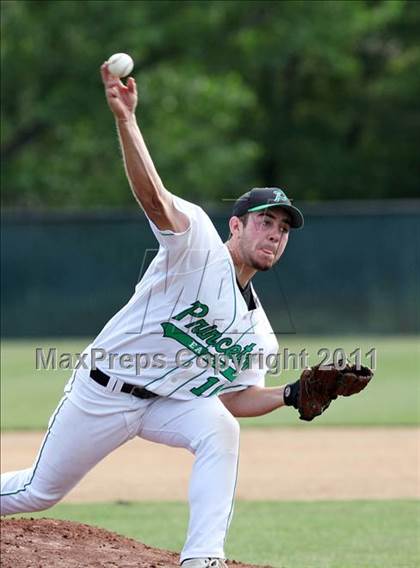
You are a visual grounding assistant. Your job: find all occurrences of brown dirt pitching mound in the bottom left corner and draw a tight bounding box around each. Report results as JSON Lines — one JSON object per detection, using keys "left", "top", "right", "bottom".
{"left": 1, "top": 519, "right": 269, "bottom": 568}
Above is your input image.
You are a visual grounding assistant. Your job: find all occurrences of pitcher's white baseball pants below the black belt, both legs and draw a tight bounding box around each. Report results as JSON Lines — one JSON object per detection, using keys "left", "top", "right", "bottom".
{"left": 0, "top": 370, "right": 239, "bottom": 561}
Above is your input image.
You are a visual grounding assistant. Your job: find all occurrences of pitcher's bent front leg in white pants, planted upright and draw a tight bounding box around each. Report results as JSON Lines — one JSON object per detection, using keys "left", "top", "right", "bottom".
{"left": 139, "top": 397, "right": 239, "bottom": 561}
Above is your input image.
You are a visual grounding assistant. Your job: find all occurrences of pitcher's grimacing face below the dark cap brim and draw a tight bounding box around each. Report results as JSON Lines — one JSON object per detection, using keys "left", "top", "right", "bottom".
{"left": 239, "top": 207, "right": 290, "bottom": 271}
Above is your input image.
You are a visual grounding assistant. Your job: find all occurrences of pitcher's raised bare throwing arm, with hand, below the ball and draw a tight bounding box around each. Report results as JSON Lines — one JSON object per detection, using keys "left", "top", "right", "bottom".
{"left": 101, "top": 63, "right": 189, "bottom": 233}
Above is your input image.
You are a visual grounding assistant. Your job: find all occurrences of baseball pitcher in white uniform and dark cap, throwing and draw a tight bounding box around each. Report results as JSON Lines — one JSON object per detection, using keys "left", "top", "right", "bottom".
{"left": 1, "top": 63, "right": 370, "bottom": 568}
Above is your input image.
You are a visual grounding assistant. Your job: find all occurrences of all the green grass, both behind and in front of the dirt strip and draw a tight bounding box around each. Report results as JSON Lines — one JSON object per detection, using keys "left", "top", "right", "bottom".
{"left": 1, "top": 337, "right": 420, "bottom": 568}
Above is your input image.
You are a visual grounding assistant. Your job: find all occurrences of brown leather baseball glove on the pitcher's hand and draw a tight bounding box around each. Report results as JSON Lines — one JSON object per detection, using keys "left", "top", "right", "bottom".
{"left": 297, "top": 364, "right": 373, "bottom": 421}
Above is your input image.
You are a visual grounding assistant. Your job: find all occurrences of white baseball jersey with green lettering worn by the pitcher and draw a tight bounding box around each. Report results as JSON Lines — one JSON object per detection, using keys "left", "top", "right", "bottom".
{"left": 86, "top": 197, "right": 278, "bottom": 400}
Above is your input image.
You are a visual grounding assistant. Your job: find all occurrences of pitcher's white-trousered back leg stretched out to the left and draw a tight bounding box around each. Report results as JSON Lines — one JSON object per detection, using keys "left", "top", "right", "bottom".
{"left": 0, "top": 378, "right": 144, "bottom": 515}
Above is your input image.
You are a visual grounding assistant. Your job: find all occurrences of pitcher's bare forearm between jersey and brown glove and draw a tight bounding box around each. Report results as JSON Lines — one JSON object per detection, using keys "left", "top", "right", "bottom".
{"left": 220, "top": 386, "right": 285, "bottom": 417}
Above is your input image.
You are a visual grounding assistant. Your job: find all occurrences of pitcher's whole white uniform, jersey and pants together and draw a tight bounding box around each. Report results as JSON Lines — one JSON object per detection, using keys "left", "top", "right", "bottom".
{"left": 1, "top": 197, "right": 277, "bottom": 561}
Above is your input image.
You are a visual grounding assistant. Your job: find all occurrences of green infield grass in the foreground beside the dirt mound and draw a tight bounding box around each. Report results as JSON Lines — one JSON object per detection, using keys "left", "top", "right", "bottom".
{"left": 20, "top": 501, "right": 420, "bottom": 568}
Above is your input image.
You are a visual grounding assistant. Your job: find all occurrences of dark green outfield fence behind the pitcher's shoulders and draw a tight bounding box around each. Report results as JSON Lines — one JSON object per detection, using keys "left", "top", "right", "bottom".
{"left": 1, "top": 201, "right": 420, "bottom": 337}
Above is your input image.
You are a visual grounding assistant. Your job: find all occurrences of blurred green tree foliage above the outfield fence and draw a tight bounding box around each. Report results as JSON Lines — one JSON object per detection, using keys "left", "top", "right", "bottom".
{"left": 1, "top": 0, "right": 420, "bottom": 209}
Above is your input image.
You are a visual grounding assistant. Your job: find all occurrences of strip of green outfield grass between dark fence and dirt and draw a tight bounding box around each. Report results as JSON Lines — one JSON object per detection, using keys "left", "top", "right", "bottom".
{"left": 1, "top": 337, "right": 420, "bottom": 430}
